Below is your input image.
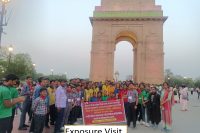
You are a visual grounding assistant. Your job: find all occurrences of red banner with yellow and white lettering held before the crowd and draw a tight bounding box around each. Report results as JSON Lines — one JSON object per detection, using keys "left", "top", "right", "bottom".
{"left": 82, "top": 100, "right": 126, "bottom": 125}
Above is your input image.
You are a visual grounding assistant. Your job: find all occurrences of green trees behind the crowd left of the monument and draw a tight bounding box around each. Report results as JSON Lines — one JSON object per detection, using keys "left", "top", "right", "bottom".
{"left": 0, "top": 47, "right": 67, "bottom": 80}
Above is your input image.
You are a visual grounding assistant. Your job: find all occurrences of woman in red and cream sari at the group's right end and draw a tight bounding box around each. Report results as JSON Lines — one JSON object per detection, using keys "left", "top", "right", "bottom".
{"left": 161, "top": 82, "right": 173, "bottom": 132}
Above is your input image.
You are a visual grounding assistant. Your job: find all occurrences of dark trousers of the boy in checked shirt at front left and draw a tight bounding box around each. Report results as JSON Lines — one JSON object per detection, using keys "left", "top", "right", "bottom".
{"left": 34, "top": 114, "right": 45, "bottom": 133}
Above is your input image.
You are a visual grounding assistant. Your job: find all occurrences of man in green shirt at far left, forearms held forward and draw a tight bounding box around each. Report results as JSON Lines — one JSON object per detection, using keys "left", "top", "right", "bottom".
{"left": 0, "top": 74, "right": 24, "bottom": 133}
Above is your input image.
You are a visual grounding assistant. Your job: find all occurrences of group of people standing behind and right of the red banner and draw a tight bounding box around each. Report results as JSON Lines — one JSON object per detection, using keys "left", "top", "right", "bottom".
{"left": 84, "top": 81, "right": 174, "bottom": 132}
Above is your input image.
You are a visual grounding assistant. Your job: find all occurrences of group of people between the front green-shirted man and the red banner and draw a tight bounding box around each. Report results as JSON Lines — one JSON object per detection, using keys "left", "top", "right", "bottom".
{"left": 18, "top": 77, "right": 82, "bottom": 133}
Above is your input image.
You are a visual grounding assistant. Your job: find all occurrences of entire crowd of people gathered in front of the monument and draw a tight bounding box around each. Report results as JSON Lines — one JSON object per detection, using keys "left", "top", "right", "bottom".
{"left": 0, "top": 74, "right": 198, "bottom": 133}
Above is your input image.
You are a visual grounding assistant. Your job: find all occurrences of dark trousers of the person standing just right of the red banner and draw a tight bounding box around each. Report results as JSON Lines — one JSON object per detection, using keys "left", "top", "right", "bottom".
{"left": 127, "top": 102, "right": 136, "bottom": 127}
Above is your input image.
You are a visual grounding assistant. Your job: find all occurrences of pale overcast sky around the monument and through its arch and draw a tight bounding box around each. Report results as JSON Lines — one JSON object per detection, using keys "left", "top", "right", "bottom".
{"left": 2, "top": 0, "right": 200, "bottom": 79}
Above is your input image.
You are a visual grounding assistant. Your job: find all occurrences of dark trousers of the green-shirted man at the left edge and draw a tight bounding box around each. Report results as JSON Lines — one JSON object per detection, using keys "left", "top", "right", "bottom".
{"left": 0, "top": 117, "right": 11, "bottom": 133}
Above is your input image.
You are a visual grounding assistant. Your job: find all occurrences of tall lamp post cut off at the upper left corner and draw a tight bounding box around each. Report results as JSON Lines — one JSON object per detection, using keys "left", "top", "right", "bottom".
{"left": 0, "top": 0, "right": 10, "bottom": 48}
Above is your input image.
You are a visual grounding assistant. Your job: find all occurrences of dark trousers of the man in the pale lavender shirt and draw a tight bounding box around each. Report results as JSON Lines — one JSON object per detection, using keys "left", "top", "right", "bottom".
{"left": 54, "top": 108, "right": 65, "bottom": 133}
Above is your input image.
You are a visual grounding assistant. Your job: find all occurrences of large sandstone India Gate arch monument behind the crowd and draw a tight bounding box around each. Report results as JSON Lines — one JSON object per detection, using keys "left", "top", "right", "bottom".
{"left": 90, "top": 0, "right": 167, "bottom": 84}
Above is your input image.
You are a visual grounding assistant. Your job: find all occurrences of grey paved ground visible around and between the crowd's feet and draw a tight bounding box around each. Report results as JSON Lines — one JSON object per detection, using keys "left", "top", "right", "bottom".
{"left": 13, "top": 93, "right": 200, "bottom": 133}
